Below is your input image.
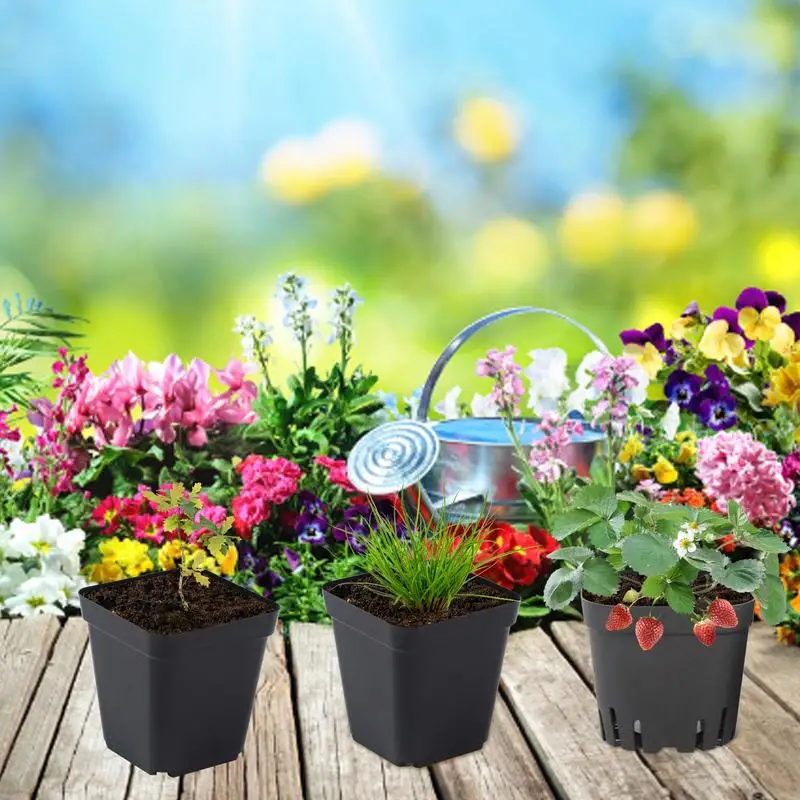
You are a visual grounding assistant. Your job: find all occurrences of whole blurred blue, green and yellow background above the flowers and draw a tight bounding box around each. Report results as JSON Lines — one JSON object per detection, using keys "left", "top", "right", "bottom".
{"left": 0, "top": 0, "right": 800, "bottom": 394}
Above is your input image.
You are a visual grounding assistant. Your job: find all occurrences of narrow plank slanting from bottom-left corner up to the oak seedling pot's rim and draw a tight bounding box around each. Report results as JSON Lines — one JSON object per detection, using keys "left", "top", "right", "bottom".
{"left": 0, "top": 617, "right": 88, "bottom": 799}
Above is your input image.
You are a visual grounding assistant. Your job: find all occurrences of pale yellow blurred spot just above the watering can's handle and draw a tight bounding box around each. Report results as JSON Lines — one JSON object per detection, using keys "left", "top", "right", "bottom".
{"left": 472, "top": 217, "right": 550, "bottom": 283}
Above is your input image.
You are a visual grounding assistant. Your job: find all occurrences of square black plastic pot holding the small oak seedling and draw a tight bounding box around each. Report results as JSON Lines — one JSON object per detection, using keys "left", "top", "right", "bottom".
{"left": 80, "top": 573, "right": 278, "bottom": 776}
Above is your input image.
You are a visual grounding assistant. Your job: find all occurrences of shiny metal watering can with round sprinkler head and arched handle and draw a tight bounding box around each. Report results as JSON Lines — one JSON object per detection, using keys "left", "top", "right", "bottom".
{"left": 347, "top": 306, "right": 608, "bottom": 523}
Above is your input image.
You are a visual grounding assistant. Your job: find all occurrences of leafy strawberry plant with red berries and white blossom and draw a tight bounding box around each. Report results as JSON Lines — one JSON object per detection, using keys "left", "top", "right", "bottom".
{"left": 544, "top": 485, "right": 788, "bottom": 650}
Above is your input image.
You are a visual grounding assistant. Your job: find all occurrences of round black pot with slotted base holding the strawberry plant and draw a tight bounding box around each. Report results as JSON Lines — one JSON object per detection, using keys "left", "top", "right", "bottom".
{"left": 582, "top": 598, "right": 753, "bottom": 753}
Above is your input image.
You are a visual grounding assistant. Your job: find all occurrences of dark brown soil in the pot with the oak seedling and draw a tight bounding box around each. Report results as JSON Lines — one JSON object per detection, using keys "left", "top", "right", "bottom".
{"left": 85, "top": 570, "right": 277, "bottom": 634}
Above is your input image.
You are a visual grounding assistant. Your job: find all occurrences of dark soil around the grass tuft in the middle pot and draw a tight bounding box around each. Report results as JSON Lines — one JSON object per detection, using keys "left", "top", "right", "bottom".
{"left": 329, "top": 575, "right": 511, "bottom": 628}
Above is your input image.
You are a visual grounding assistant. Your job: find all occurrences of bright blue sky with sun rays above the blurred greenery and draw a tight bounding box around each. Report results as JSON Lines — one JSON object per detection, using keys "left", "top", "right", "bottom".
{"left": 0, "top": 0, "right": 750, "bottom": 196}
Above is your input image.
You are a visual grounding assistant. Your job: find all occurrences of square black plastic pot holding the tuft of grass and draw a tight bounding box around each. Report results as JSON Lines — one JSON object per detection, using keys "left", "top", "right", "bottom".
{"left": 323, "top": 578, "right": 520, "bottom": 767}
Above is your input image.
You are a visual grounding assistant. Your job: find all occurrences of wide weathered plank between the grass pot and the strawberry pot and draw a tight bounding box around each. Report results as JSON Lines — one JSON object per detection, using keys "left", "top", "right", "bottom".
{"left": 502, "top": 629, "right": 669, "bottom": 800}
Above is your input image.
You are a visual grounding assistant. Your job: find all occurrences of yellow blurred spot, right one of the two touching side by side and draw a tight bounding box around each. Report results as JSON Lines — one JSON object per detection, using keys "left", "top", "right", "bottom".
{"left": 627, "top": 191, "right": 697, "bottom": 257}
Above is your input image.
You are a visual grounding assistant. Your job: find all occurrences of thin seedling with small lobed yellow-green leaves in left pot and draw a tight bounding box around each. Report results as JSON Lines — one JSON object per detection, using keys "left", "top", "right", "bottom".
{"left": 144, "top": 483, "right": 236, "bottom": 611}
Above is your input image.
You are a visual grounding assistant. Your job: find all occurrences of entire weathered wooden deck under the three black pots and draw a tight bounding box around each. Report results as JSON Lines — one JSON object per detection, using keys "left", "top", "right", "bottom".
{"left": 0, "top": 618, "right": 800, "bottom": 800}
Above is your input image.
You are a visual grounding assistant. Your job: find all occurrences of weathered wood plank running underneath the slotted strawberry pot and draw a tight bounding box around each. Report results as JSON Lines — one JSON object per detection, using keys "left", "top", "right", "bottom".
{"left": 550, "top": 622, "right": 780, "bottom": 800}
